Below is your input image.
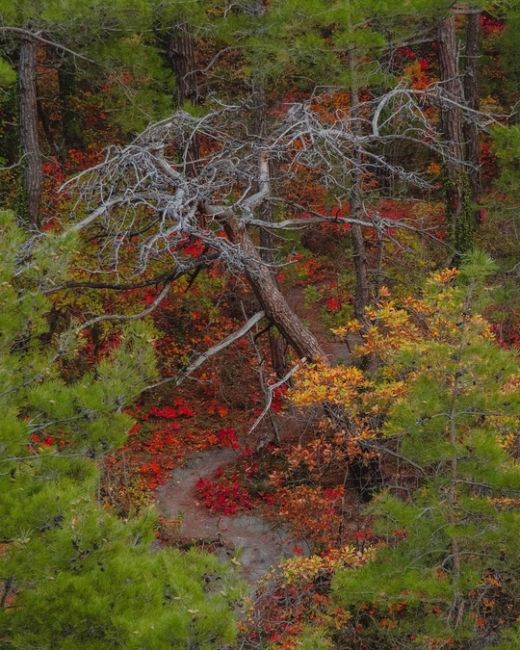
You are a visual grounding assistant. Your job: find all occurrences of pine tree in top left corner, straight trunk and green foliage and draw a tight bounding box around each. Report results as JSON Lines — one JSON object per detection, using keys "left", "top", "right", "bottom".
{"left": 0, "top": 0, "right": 175, "bottom": 228}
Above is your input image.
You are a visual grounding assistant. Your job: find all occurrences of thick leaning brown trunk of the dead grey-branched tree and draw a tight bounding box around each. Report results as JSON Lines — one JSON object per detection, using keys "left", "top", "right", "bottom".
{"left": 224, "top": 219, "right": 328, "bottom": 363}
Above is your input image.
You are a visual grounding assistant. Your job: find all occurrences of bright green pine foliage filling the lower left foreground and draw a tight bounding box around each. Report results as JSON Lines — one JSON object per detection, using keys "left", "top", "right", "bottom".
{"left": 0, "top": 213, "right": 238, "bottom": 650}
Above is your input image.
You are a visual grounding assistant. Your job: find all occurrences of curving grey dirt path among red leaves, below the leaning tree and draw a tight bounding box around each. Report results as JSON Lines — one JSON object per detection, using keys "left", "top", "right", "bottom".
{"left": 157, "top": 448, "right": 307, "bottom": 586}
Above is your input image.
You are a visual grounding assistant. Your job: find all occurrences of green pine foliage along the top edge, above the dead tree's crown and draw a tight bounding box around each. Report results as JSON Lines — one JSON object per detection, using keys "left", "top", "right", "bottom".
{"left": 178, "top": 0, "right": 448, "bottom": 91}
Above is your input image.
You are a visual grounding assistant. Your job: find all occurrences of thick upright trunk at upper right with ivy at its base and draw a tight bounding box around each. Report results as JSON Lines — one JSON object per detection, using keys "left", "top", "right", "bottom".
{"left": 438, "top": 13, "right": 473, "bottom": 261}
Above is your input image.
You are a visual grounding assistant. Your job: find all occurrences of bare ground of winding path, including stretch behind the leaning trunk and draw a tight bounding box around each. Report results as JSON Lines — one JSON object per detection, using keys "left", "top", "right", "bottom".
{"left": 156, "top": 285, "right": 358, "bottom": 588}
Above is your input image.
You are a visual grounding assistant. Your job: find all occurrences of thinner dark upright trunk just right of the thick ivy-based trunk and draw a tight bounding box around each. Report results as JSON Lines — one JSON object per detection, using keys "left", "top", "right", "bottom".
{"left": 464, "top": 9, "right": 481, "bottom": 211}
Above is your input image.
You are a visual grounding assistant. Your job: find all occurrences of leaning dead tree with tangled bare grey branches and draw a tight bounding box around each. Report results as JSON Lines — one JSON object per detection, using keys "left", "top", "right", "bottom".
{"left": 62, "top": 86, "right": 492, "bottom": 362}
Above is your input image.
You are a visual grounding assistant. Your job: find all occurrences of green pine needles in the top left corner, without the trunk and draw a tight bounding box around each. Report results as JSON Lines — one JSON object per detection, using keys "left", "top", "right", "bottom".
{"left": 0, "top": 0, "right": 175, "bottom": 140}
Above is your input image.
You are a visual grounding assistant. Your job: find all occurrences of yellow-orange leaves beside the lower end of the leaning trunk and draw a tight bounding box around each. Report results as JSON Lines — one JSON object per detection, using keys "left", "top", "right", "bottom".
{"left": 289, "top": 269, "right": 498, "bottom": 446}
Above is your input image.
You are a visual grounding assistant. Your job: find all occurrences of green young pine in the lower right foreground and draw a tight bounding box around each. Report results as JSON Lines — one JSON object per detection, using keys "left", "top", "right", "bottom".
{"left": 334, "top": 253, "right": 520, "bottom": 648}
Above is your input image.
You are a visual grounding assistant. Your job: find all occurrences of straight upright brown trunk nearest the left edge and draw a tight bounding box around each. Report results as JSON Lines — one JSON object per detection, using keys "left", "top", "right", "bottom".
{"left": 18, "top": 38, "right": 43, "bottom": 228}
